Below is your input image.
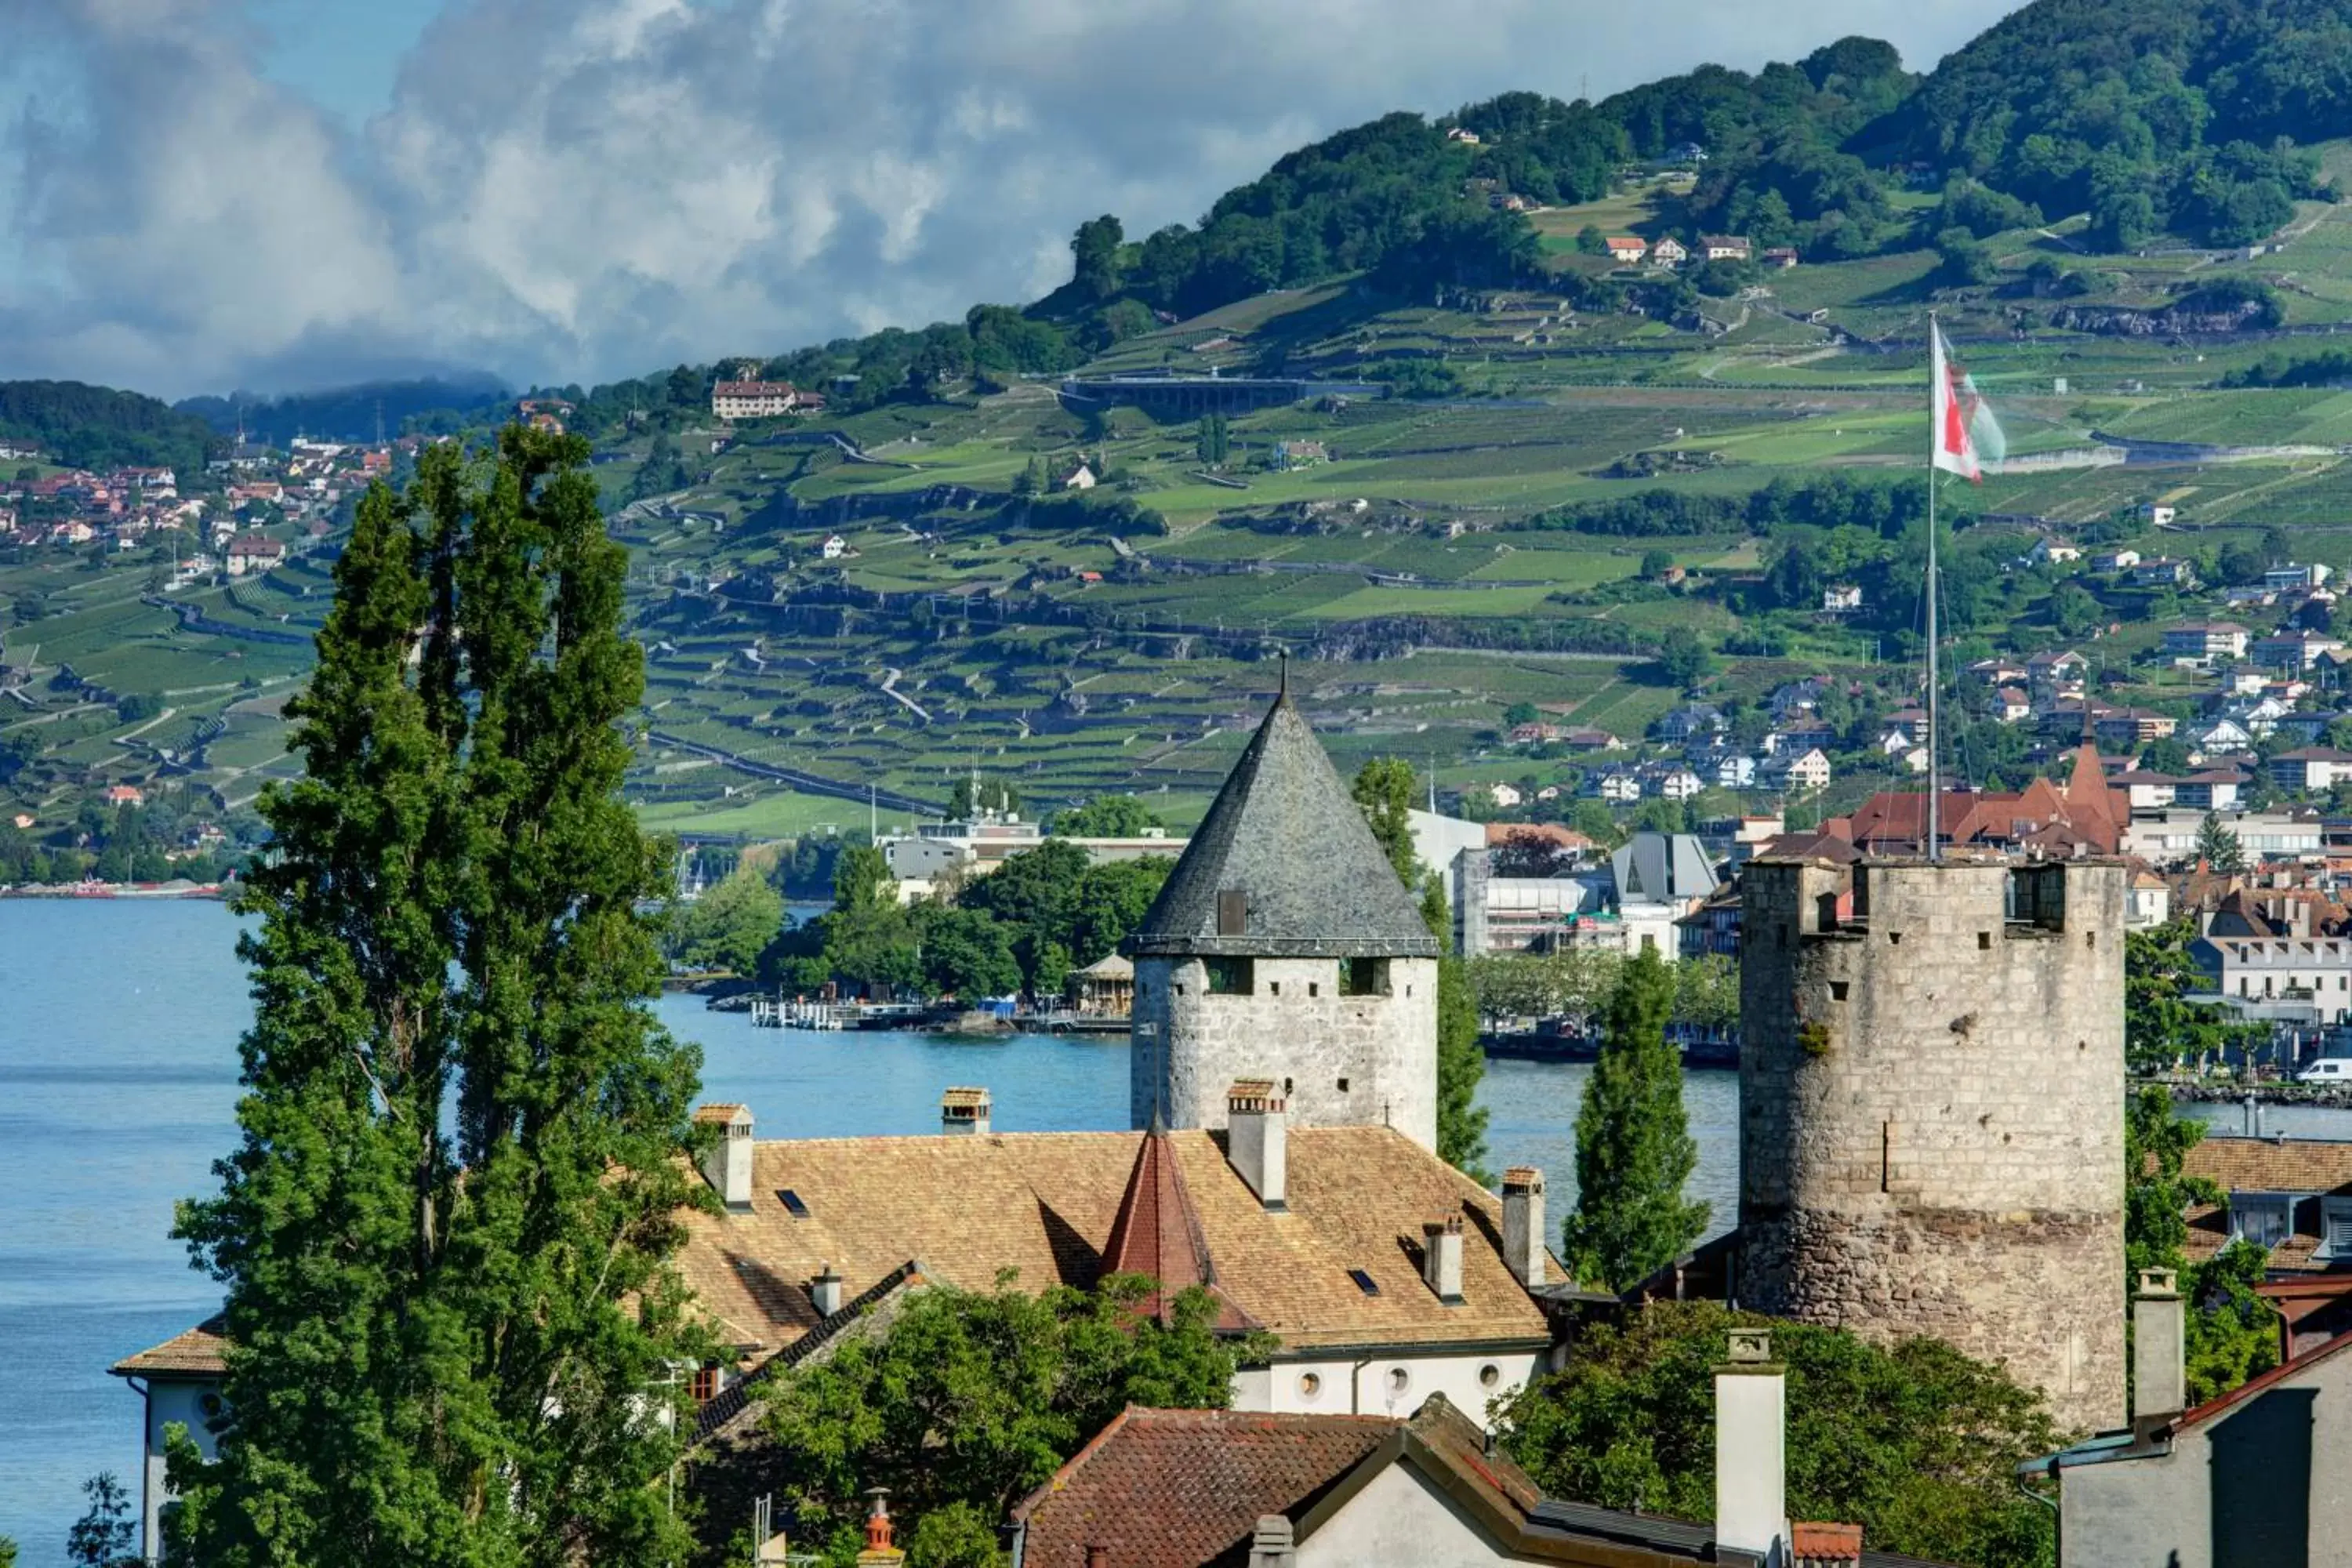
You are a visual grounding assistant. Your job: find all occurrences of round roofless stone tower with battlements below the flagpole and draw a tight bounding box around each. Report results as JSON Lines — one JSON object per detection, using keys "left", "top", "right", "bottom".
{"left": 1733, "top": 858, "right": 2126, "bottom": 1429}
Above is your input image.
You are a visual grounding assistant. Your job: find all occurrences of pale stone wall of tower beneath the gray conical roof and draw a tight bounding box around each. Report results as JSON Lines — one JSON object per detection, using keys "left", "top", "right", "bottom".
{"left": 1129, "top": 956, "right": 1437, "bottom": 1149}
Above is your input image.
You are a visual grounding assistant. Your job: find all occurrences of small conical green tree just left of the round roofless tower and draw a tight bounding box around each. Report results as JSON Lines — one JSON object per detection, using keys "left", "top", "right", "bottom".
{"left": 1562, "top": 947, "right": 1708, "bottom": 1290}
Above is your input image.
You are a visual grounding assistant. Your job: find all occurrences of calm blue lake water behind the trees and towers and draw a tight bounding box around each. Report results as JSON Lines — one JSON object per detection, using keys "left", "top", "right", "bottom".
{"left": 0, "top": 900, "right": 1740, "bottom": 1568}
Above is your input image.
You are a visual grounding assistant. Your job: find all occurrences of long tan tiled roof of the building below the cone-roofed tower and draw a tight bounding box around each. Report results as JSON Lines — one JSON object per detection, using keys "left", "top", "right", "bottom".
{"left": 680, "top": 1126, "right": 1545, "bottom": 1361}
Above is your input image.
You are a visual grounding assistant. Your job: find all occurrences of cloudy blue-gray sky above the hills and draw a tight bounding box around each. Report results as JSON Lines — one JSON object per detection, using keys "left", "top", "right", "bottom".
{"left": 0, "top": 0, "right": 2013, "bottom": 397}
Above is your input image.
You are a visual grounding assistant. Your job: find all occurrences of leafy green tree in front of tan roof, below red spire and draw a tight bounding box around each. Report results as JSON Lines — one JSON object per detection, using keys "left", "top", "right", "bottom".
{"left": 767, "top": 1274, "right": 1272, "bottom": 1561}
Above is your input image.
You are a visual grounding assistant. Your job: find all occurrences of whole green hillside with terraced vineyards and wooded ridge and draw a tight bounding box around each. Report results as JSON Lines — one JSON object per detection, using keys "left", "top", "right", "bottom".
{"left": 23, "top": 0, "right": 2352, "bottom": 837}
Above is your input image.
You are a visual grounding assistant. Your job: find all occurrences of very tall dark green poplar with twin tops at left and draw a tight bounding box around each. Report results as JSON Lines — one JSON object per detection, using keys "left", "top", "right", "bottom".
{"left": 174, "top": 428, "right": 703, "bottom": 1568}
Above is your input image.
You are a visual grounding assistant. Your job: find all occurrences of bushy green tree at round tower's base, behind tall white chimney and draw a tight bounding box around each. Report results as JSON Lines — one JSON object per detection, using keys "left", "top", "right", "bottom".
{"left": 1498, "top": 1302, "right": 2058, "bottom": 1568}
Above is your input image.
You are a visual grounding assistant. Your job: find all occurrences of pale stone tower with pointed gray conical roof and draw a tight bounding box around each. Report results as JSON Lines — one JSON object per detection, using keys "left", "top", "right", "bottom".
{"left": 1131, "top": 694, "right": 1437, "bottom": 1149}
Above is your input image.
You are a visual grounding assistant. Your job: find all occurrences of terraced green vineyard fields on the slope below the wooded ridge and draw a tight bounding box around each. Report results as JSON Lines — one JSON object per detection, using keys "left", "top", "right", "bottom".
{"left": 23, "top": 146, "right": 2352, "bottom": 837}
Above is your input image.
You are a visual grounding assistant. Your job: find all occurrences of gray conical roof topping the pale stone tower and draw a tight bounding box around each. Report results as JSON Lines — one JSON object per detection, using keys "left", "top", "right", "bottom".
{"left": 1134, "top": 694, "right": 1437, "bottom": 956}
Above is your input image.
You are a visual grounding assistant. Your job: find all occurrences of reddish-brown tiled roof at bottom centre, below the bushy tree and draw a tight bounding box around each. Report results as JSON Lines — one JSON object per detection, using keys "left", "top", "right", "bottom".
{"left": 1014, "top": 1406, "right": 1404, "bottom": 1568}
